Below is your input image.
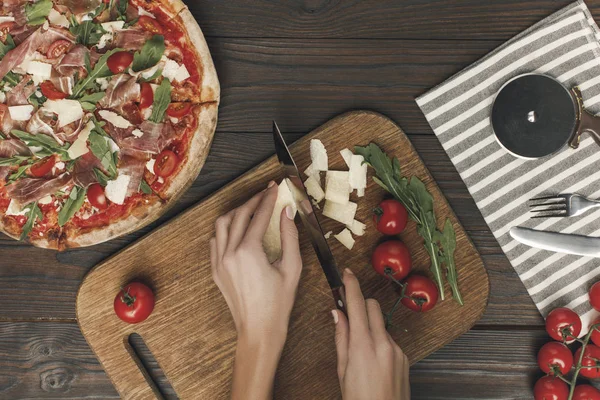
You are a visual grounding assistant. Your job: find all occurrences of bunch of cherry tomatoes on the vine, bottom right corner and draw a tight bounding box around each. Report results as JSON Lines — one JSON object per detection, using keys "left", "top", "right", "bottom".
{"left": 533, "top": 282, "right": 600, "bottom": 400}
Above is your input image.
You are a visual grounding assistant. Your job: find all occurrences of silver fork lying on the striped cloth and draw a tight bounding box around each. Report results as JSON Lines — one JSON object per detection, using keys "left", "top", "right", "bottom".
{"left": 529, "top": 194, "right": 600, "bottom": 218}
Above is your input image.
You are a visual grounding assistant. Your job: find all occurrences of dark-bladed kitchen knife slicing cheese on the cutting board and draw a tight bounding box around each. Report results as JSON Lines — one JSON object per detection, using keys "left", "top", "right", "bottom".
{"left": 273, "top": 121, "right": 348, "bottom": 315}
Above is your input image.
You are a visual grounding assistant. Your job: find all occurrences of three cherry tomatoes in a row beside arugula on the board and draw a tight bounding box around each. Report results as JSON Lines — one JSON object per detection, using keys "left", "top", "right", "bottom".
{"left": 371, "top": 199, "right": 438, "bottom": 312}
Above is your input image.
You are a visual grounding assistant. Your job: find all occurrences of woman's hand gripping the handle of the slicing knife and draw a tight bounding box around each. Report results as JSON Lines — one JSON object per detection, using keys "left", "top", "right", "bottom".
{"left": 332, "top": 269, "right": 410, "bottom": 400}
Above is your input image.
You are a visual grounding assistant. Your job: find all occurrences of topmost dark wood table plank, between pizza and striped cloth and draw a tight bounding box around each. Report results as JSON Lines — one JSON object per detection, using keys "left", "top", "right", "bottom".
{"left": 192, "top": 0, "right": 584, "bottom": 40}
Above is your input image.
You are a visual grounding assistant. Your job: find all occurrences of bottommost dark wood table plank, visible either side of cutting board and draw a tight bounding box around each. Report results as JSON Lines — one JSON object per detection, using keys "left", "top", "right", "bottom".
{"left": 0, "top": 323, "right": 548, "bottom": 400}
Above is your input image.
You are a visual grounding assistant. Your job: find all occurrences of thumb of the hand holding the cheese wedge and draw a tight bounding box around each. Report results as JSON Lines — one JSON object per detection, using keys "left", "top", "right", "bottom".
{"left": 280, "top": 206, "right": 302, "bottom": 282}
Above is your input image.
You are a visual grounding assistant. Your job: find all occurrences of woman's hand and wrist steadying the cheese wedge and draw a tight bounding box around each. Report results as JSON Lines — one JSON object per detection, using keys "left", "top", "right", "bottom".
{"left": 210, "top": 182, "right": 302, "bottom": 399}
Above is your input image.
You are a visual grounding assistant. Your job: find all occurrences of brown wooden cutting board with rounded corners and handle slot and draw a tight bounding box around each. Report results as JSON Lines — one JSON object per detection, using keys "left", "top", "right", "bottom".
{"left": 77, "top": 111, "right": 489, "bottom": 400}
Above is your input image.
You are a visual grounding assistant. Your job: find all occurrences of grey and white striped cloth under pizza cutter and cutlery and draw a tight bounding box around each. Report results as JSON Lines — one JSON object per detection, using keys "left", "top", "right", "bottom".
{"left": 417, "top": 1, "right": 600, "bottom": 326}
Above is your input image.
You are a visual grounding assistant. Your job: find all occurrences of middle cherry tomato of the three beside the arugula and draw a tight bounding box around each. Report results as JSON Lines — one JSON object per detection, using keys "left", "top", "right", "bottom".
{"left": 371, "top": 240, "right": 412, "bottom": 281}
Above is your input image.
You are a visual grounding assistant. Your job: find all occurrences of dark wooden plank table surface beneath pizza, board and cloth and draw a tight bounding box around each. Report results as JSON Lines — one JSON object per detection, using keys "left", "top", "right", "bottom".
{"left": 0, "top": 0, "right": 600, "bottom": 400}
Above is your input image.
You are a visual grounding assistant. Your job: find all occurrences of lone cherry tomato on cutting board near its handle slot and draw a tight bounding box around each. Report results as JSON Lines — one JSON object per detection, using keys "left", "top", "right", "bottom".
{"left": 114, "top": 282, "right": 154, "bottom": 324}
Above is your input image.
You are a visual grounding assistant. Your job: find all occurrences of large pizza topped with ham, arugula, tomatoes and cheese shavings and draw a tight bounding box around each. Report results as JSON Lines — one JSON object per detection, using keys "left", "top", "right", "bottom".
{"left": 0, "top": 0, "right": 220, "bottom": 250}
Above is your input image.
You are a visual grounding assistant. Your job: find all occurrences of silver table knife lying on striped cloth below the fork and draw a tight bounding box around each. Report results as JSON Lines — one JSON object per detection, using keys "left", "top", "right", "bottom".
{"left": 510, "top": 227, "right": 600, "bottom": 257}
